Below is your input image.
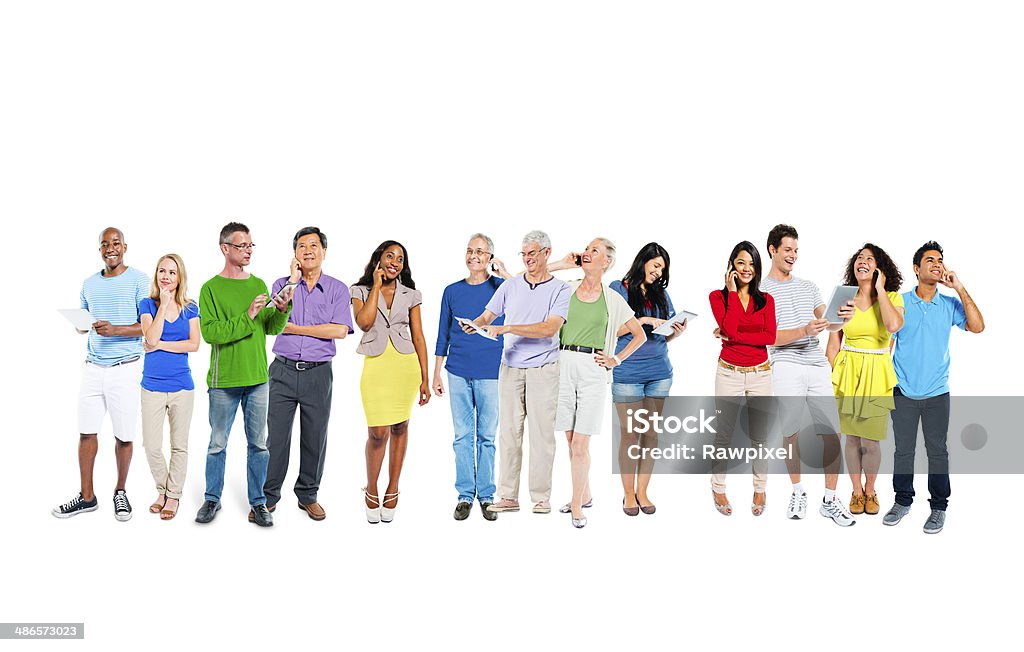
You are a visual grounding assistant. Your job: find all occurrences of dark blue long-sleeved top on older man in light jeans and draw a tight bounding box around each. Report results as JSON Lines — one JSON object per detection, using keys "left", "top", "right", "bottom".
{"left": 434, "top": 276, "right": 505, "bottom": 380}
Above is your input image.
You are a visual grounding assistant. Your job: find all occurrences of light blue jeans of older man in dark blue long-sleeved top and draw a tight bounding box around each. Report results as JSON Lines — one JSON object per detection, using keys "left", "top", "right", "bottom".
{"left": 447, "top": 374, "right": 498, "bottom": 503}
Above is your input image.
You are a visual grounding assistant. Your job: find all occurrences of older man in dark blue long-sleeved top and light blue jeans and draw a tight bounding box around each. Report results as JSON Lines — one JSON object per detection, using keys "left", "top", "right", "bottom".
{"left": 431, "top": 233, "right": 507, "bottom": 521}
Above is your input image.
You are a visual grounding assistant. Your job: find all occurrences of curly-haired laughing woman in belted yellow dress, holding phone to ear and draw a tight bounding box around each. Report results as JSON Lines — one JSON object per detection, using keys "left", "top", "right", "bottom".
{"left": 825, "top": 243, "right": 903, "bottom": 514}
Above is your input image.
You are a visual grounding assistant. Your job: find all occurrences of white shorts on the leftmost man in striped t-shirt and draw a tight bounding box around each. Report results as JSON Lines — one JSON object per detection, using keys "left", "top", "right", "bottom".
{"left": 78, "top": 357, "right": 142, "bottom": 441}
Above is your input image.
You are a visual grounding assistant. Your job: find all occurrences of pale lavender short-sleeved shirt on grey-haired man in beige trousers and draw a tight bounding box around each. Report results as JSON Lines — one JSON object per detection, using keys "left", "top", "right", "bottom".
{"left": 485, "top": 274, "right": 572, "bottom": 368}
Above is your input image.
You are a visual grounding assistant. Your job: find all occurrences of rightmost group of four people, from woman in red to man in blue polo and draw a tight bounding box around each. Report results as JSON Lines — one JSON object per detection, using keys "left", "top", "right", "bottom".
{"left": 710, "top": 224, "right": 985, "bottom": 533}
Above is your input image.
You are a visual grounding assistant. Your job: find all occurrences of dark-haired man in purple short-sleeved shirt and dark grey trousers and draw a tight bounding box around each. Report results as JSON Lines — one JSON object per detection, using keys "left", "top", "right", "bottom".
{"left": 263, "top": 226, "right": 352, "bottom": 521}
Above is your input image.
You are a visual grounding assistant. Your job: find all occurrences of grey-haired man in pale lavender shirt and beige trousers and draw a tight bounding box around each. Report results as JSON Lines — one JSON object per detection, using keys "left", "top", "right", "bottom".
{"left": 466, "top": 231, "right": 571, "bottom": 514}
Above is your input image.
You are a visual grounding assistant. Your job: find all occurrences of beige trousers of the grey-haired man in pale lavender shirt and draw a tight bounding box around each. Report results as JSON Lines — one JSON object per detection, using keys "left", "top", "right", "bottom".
{"left": 498, "top": 361, "right": 559, "bottom": 503}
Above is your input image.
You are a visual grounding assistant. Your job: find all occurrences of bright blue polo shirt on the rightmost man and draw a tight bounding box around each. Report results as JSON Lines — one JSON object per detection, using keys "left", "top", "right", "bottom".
{"left": 893, "top": 288, "right": 967, "bottom": 400}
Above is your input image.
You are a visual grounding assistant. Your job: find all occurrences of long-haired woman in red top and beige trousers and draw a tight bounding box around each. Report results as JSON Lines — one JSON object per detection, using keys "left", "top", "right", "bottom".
{"left": 709, "top": 241, "right": 776, "bottom": 516}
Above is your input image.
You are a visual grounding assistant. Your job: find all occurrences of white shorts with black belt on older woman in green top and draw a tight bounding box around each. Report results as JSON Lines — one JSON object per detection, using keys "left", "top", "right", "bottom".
{"left": 555, "top": 351, "right": 608, "bottom": 435}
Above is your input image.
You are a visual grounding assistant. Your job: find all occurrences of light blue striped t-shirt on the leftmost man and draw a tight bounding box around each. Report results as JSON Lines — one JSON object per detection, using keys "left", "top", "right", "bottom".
{"left": 79, "top": 267, "right": 150, "bottom": 366}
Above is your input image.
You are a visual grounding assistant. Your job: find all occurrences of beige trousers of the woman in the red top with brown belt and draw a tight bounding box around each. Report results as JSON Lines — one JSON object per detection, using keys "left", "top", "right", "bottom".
{"left": 711, "top": 364, "right": 772, "bottom": 493}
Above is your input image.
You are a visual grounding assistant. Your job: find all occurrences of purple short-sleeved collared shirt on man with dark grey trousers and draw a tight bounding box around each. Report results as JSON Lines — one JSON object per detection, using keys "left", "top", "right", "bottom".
{"left": 270, "top": 273, "right": 353, "bottom": 362}
